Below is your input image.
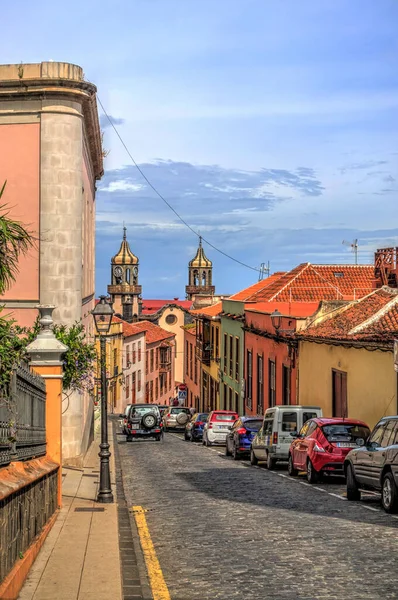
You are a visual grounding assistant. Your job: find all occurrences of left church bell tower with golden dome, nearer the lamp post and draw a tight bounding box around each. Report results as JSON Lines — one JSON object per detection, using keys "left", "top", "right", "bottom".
{"left": 108, "top": 227, "right": 142, "bottom": 323}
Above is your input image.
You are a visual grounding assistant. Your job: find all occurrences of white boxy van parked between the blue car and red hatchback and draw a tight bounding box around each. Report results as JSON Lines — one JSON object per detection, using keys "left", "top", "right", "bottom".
{"left": 250, "top": 404, "right": 322, "bottom": 469}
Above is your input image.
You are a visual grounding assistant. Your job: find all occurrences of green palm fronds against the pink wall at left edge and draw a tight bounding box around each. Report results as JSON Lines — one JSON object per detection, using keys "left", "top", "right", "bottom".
{"left": 0, "top": 181, "right": 33, "bottom": 295}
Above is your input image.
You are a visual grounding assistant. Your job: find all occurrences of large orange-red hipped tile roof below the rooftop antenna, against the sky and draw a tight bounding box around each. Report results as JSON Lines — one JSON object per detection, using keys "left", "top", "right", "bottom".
{"left": 247, "top": 263, "right": 374, "bottom": 302}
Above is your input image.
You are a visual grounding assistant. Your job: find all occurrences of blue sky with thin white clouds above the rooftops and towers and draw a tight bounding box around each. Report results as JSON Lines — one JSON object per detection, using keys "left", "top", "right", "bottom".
{"left": 0, "top": 0, "right": 398, "bottom": 298}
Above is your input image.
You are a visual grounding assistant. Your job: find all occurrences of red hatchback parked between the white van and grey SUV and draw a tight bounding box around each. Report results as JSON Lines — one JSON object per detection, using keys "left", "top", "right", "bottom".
{"left": 288, "top": 417, "right": 370, "bottom": 483}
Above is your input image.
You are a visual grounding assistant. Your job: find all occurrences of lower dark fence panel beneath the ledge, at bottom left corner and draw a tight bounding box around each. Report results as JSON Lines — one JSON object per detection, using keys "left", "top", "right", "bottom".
{"left": 0, "top": 470, "right": 58, "bottom": 582}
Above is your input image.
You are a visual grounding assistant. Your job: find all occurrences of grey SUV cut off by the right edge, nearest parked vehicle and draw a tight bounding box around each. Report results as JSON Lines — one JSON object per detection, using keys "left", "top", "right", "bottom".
{"left": 344, "top": 416, "right": 398, "bottom": 513}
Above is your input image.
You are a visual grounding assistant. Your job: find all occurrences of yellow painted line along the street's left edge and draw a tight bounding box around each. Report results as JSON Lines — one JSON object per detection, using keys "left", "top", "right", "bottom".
{"left": 132, "top": 506, "right": 171, "bottom": 600}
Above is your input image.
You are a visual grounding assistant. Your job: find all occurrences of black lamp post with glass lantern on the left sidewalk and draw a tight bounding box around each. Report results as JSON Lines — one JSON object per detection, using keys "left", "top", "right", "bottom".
{"left": 91, "top": 296, "right": 115, "bottom": 504}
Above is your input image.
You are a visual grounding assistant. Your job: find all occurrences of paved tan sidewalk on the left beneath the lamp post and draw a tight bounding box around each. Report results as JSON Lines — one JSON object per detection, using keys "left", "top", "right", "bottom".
{"left": 19, "top": 424, "right": 123, "bottom": 600}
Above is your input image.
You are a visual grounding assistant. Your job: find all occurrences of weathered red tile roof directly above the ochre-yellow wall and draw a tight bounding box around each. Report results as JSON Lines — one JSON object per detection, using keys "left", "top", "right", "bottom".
{"left": 301, "top": 286, "right": 398, "bottom": 342}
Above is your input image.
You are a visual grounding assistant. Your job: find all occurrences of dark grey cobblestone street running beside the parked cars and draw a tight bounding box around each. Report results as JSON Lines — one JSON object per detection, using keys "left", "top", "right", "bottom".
{"left": 119, "top": 434, "right": 398, "bottom": 600}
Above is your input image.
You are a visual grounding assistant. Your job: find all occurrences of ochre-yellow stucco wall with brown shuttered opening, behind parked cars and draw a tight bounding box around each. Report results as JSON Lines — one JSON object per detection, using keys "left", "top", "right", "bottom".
{"left": 298, "top": 341, "right": 398, "bottom": 427}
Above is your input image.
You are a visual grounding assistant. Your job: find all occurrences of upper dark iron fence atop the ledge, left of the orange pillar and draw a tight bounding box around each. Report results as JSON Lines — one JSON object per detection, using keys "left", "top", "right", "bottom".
{"left": 0, "top": 363, "right": 46, "bottom": 466}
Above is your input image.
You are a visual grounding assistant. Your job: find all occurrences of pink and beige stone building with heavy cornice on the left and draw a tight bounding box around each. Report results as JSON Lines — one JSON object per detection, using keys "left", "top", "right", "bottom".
{"left": 0, "top": 62, "right": 103, "bottom": 463}
